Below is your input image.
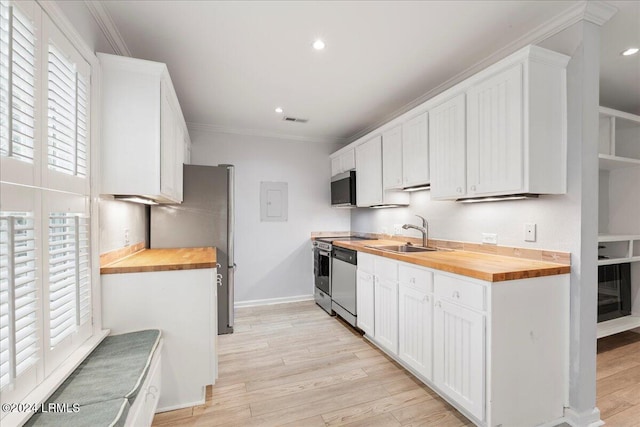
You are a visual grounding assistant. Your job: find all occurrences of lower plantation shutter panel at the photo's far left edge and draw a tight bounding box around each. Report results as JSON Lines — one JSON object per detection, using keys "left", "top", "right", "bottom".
{"left": 0, "top": 212, "right": 39, "bottom": 388}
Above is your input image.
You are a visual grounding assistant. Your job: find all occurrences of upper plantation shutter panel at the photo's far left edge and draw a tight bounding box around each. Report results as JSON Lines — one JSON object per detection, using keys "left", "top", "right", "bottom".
{"left": 0, "top": 0, "right": 36, "bottom": 163}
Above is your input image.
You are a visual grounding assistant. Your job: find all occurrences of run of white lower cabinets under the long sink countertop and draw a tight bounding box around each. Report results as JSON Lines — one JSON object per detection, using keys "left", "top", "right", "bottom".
{"left": 358, "top": 252, "right": 569, "bottom": 427}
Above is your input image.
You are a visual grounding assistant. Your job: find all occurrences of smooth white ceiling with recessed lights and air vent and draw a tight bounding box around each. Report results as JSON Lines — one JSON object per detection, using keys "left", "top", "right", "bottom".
{"left": 97, "top": 1, "right": 640, "bottom": 141}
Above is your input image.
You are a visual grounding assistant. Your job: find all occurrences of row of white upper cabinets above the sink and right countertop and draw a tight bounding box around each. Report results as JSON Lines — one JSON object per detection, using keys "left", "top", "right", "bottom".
{"left": 332, "top": 46, "right": 568, "bottom": 206}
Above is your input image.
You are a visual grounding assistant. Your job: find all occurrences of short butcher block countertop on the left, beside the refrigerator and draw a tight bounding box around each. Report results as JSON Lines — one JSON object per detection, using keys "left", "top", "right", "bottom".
{"left": 100, "top": 247, "right": 216, "bottom": 274}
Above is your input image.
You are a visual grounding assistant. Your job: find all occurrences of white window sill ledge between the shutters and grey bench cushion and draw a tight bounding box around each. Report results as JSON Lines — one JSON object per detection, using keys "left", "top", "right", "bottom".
{"left": 2, "top": 329, "right": 110, "bottom": 426}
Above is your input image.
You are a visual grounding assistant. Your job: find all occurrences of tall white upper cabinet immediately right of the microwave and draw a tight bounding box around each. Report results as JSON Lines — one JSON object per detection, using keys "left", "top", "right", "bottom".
{"left": 356, "top": 135, "right": 410, "bottom": 207}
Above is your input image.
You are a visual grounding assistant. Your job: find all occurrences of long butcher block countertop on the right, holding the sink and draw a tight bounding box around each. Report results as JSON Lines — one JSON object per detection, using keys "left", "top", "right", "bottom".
{"left": 333, "top": 240, "right": 571, "bottom": 282}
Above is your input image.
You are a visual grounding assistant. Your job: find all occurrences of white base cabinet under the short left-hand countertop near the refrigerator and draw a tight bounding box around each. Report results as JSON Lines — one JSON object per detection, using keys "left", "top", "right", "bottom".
{"left": 100, "top": 268, "right": 218, "bottom": 412}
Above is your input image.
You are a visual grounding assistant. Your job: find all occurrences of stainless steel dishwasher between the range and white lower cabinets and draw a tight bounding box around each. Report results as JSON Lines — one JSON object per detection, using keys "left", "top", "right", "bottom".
{"left": 331, "top": 245, "right": 357, "bottom": 327}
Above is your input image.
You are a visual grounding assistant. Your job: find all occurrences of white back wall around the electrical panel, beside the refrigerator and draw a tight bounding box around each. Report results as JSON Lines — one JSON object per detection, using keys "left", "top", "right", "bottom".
{"left": 189, "top": 130, "right": 350, "bottom": 302}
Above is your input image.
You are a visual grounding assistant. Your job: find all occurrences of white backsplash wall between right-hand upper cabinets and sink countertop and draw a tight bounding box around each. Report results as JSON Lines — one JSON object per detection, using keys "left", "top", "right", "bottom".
{"left": 351, "top": 191, "right": 580, "bottom": 252}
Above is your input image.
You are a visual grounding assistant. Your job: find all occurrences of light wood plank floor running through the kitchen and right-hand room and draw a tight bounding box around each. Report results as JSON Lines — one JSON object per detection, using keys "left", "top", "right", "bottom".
{"left": 153, "top": 302, "right": 640, "bottom": 427}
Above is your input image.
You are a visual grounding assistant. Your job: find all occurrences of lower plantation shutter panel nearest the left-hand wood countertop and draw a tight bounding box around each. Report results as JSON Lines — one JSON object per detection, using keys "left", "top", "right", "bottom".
{"left": 49, "top": 213, "right": 91, "bottom": 348}
